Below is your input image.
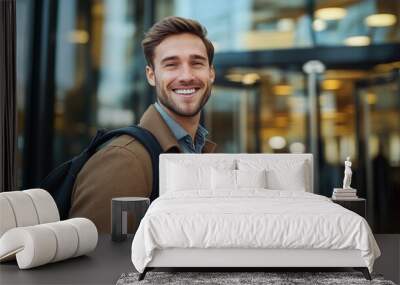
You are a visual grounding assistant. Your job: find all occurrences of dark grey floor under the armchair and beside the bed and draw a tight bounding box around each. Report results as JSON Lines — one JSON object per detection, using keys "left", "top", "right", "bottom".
{"left": 0, "top": 235, "right": 400, "bottom": 285}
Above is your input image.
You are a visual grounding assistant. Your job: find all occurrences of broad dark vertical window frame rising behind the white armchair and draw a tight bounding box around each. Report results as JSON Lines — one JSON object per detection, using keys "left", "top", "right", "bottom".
{"left": 22, "top": 0, "right": 58, "bottom": 188}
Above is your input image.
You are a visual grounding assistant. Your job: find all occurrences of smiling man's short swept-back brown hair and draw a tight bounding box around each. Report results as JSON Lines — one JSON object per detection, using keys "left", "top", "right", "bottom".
{"left": 142, "top": 17, "right": 214, "bottom": 67}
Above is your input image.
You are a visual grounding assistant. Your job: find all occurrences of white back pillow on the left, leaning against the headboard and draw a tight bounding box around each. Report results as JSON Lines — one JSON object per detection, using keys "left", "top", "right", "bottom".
{"left": 167, "top": 163, "right": 211, "bottom": 191}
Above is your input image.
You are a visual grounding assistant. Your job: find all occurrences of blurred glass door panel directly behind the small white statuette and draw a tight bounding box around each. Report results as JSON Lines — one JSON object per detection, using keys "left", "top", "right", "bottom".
{"left": 316, "top": 69, "right": 362, "bottom": 197}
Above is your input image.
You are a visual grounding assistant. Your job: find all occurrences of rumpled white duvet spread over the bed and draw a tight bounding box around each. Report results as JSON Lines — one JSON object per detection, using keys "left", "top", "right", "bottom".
{"left": 132, "top": 189, "right": 380, "bottom": 272}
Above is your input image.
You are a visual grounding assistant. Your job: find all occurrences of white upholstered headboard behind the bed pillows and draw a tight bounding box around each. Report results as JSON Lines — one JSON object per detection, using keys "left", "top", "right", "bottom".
{"left": 159, "top": 153, "right": 314, "bottom": 196}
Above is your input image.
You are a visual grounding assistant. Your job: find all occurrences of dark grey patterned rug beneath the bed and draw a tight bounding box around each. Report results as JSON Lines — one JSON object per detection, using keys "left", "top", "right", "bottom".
{"left": 117, "top": 271, "right": 395, "bottom": 285}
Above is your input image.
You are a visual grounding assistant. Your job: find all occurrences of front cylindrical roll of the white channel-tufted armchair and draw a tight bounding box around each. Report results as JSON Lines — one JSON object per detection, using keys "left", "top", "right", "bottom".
{"left": 0, "top": 218, "right": 98, "bottom": 269}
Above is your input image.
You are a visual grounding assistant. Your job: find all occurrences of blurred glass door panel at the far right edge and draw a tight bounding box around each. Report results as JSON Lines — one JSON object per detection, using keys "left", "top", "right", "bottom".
{"left": 357, "top": 67, "right": 400, "bottom": 233}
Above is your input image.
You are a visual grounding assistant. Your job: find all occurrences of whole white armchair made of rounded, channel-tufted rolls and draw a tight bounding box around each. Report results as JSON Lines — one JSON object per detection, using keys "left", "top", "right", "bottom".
{"left": 0, "top": 189, "right": 98, "bottom": 269}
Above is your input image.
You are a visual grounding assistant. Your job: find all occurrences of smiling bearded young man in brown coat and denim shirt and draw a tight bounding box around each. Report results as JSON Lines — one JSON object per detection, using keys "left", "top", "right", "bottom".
{"left": 70, "top": 17, "right": 215, "bottom": 232}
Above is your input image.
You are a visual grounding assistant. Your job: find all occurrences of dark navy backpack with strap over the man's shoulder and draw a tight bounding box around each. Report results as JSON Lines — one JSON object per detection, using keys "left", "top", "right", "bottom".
{"left": 40, "top": 126, "right": 162, "bottom": 219}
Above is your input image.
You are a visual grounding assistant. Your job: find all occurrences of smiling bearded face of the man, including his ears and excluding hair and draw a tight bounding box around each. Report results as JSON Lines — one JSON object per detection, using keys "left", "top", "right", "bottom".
{"left": 146, "top": 33, "right": 215, "bottom": 117}
